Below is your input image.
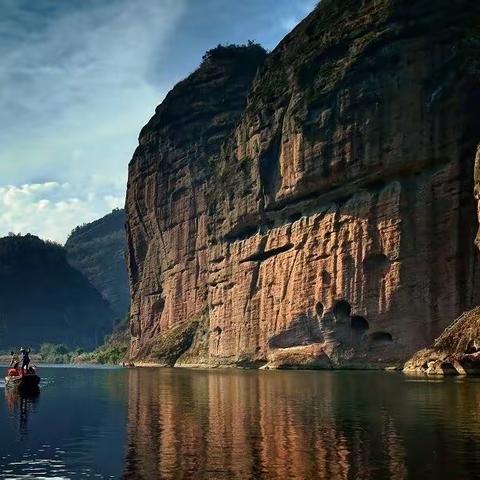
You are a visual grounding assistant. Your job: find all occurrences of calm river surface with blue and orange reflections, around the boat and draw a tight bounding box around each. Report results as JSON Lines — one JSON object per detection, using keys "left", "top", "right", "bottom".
{"left": 0, "top": 367, "right": 480, "bottom": 480}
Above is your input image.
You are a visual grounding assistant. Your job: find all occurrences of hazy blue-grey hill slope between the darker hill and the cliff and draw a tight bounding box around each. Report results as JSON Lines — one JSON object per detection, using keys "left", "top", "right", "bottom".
{"left": 65, "top": 209, "right": 130, "bottom": 320}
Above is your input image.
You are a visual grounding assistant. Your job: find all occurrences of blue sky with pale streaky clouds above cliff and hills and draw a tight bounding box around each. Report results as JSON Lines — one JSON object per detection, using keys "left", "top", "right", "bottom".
{"left": 0, "top": 0, "right": 317, "bottom": 243}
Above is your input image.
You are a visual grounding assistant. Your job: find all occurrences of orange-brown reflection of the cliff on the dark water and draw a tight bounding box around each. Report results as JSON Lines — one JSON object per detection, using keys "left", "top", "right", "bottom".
{"left": 124, "top": 370, "right": 480, "bottom": 480}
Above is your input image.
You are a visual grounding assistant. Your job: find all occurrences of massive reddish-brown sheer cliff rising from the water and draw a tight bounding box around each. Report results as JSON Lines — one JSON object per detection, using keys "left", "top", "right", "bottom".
{"left": 127, "top": 0, "right": 480, "bottom": 368}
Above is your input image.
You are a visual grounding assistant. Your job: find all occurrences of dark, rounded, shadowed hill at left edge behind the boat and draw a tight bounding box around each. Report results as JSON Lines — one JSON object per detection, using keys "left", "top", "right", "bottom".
{"left": 0, "top": 235, "right": 115, "bottom": 350}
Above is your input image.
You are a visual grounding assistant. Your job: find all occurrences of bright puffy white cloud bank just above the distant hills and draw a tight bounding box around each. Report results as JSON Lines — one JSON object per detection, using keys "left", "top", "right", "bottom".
{"left": 0, "top": 182, "right": 123, "bottom": 243}
